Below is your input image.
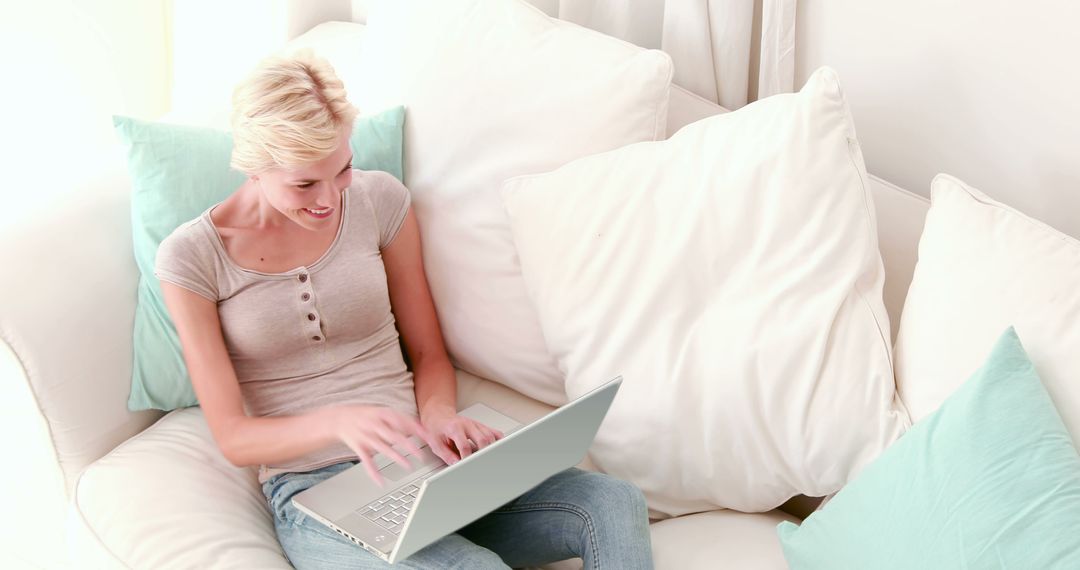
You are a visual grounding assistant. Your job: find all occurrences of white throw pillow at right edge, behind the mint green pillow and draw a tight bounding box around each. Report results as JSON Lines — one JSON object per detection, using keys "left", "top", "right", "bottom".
{"left": 896, "top": 175, "right": 1080, "bottom": 443}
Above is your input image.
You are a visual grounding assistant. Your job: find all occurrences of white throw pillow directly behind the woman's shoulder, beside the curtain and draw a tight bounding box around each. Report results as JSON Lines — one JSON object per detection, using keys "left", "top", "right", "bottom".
{"left": 350, "top": 0, "right": 672, "bottom": 405}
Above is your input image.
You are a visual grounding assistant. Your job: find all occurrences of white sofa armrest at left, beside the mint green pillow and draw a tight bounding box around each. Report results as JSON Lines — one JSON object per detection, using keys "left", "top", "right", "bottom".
{"left": 0, "top": 148, "right": 161, "bottom": 568}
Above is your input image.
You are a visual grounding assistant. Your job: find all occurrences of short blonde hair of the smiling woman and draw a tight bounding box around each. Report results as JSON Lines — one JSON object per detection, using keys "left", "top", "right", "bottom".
{"left": 230, "top": 50, "right": 357, "bottom": 174}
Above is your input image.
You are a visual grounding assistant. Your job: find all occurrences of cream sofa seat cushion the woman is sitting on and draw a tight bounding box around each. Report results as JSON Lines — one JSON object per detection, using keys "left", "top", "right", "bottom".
{"left": 68, "top": 371, "right": 795, "bottom": 570}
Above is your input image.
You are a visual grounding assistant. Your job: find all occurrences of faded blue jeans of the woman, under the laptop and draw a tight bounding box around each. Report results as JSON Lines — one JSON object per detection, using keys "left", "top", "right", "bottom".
{"left": 262, "top": 462, "right": 652, "bottom": 570}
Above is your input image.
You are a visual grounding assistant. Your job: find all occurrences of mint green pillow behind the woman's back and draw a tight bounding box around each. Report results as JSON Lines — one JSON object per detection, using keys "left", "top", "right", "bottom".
{"left": 112, "top": 107, "right": 405, "bottom": 411}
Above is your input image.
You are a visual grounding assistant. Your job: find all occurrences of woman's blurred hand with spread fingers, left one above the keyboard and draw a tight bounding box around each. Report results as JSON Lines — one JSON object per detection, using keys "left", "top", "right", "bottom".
{"left": 326, "top": 405, "right": 449, "bottom": 487}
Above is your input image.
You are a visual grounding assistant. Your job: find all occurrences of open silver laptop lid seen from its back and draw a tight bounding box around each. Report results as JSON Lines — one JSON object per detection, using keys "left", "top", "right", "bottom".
{"left": 390, "top": 377, "right": 622, "bottom": 564}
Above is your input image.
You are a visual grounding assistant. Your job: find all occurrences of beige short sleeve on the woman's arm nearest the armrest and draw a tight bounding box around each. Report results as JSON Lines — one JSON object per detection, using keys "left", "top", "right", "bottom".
{"left": 153, "top": 219, "right": 218, "bottom": 302}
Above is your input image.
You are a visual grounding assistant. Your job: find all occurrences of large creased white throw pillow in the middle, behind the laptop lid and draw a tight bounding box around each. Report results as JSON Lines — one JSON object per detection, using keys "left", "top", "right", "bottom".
{"left": 503, "top": 69, "right": 907, "bottom": 515}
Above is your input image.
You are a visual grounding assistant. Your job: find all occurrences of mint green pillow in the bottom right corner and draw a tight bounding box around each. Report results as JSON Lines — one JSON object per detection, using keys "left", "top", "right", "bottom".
{"left": 777, "top": 328, "right": 1080, "bottom": 570}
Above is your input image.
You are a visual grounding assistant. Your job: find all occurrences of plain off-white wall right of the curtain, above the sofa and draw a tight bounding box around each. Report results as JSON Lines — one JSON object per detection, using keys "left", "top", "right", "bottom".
{"left": 795, "top": 0, "right": 1080, "bottom": 238}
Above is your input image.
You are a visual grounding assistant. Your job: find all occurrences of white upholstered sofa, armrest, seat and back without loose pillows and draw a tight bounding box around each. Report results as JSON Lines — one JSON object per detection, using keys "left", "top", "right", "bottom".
{"left": 0, "top": 23, "right": 929, "bottom": 569}
